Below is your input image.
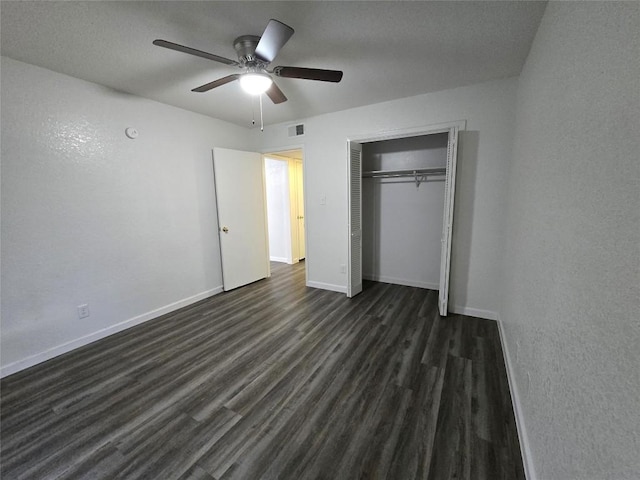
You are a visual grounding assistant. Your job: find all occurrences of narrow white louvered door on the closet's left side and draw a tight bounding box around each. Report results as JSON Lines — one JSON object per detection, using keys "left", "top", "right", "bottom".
{"left": 347, "top": 142, "right": 362, "bottom": 297}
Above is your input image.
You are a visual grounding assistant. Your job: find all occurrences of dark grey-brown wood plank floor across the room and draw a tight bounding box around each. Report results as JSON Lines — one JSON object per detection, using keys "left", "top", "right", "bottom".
{"left": 1, "top": 264, "right": 524, "bottom": 480}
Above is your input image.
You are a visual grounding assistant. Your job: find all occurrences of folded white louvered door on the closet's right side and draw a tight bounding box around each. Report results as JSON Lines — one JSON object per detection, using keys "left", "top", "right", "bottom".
{"left": 438, "top": 127, "right": 458, "bottom": 316}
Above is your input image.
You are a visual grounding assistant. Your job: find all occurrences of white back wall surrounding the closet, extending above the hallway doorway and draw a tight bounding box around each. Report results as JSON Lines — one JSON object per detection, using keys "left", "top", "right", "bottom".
{"left": 253, "top": 78, "right": 517, "bottom": 318}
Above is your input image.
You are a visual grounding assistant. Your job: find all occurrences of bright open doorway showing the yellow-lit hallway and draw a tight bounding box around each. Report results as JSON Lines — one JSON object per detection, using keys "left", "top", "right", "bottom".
{"left": 264, "top": 148, "right": 307, "bottom": 264}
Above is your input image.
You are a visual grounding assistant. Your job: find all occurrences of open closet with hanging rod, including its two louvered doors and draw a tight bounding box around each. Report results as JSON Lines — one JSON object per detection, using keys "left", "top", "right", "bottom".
{"left": 347, "top": 122, "right": 461, "bottom": 315}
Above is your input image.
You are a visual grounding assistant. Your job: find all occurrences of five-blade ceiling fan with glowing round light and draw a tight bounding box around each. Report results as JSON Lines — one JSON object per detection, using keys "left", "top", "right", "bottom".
{"left": 153, "top": 19, "right": 342, "bottom": 104}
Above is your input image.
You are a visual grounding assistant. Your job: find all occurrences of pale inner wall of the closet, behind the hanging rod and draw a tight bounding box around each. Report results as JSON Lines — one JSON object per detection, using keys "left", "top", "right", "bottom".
{"left": 362, "top": 133, "right": 448, "bottom": 290}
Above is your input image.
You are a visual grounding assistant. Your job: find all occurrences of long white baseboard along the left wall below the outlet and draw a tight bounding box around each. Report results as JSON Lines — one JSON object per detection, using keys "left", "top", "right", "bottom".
{"left": 0, "top": 286, "right": 222, "bottom": 378}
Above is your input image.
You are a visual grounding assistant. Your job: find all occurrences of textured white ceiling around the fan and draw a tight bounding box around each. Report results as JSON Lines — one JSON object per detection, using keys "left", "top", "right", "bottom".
{"left": 0, "top": 0, "right": 546, "bottom": 126}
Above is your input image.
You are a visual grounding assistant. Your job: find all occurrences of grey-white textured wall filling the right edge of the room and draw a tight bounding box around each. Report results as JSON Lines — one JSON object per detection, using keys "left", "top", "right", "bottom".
{"left": 500, "top": 2, "right": 640, "bottom": 480}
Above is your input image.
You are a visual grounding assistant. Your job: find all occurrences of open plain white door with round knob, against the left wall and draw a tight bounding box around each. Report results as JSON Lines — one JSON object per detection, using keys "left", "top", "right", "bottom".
{"left": 213, "top": 148, "right": 270, "bottom": 291}
